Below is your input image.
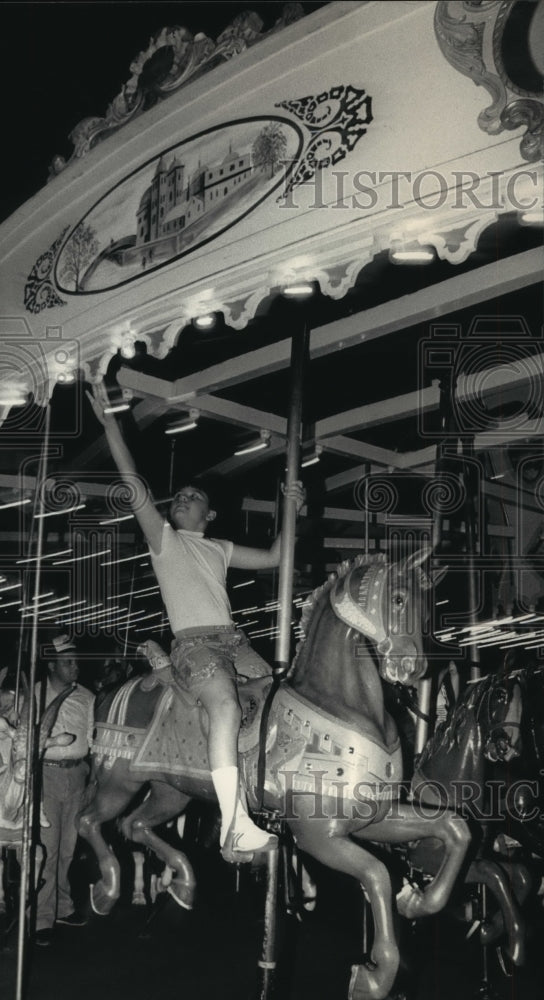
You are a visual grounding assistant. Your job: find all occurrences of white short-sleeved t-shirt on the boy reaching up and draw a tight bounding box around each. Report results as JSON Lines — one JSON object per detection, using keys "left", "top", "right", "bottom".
{"left": 149, "top": 523, "right": 234, "bottom": 633}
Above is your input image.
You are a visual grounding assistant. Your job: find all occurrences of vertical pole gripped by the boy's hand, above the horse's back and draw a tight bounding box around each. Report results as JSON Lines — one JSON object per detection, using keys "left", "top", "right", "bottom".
{"left": 275, "top": 320, "right": 310, "bottom": 677}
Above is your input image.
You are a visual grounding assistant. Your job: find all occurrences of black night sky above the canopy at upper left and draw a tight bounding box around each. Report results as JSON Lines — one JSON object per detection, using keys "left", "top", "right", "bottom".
{"left": 0, "top": 0, "right": 324, "bottom": 221}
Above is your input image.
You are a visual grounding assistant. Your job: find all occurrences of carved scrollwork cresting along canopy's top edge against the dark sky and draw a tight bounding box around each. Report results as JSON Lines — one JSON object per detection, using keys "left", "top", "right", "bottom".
{"left": 48, "top": 3, "right": 304, "bottom": 180}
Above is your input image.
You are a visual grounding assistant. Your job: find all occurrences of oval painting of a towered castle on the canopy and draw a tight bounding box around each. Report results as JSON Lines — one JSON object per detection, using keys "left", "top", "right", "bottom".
{"left": 55, "top": 117, "right": 303, "bottom": 295}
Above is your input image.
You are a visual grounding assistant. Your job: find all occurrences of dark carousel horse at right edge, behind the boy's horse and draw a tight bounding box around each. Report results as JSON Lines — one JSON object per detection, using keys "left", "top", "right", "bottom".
{"left": 408, "top": 667, "right": 544, "bottom": 965}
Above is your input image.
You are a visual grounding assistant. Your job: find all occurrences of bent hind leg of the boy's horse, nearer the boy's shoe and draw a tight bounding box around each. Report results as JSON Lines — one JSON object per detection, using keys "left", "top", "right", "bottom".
{"left": 121, "top": 781, "right": 196, "bottom": 910}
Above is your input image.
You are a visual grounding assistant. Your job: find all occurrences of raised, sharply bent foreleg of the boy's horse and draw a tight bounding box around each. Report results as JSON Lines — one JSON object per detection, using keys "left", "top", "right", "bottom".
{"left": 364, "top": 802, "right": 471, "bottom": 920}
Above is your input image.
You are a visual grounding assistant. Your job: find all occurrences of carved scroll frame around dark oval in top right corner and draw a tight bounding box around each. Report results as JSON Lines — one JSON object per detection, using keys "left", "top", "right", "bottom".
{"left": 435, "top": 0, "right": 544, "bottom": 163}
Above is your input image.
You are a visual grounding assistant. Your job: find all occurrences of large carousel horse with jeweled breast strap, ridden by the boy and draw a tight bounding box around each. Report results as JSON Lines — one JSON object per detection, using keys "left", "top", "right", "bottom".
{"left": 79, "top": 548, "right": 470, "bottom": 1000}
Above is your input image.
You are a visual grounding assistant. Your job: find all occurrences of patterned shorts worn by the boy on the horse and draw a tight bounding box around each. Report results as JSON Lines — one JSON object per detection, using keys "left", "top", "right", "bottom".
{"left": 170, "top": 625, "right": 240, "bottom": 697}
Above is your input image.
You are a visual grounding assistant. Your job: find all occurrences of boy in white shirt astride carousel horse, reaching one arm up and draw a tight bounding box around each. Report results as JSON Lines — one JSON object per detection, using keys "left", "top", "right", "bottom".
{"left": 87, "top": 388, "right": 305, "bottom": 862}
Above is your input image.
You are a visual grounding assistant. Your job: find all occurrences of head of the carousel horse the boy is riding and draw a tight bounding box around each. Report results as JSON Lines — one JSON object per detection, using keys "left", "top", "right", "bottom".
{"left": 331, "top": 547, "right": 432, "bottom": 684}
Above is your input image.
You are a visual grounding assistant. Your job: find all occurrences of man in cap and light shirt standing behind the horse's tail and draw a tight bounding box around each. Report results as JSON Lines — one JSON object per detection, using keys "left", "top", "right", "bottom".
{"left": 35, "top": 635, "right": 94, "bottom": 947}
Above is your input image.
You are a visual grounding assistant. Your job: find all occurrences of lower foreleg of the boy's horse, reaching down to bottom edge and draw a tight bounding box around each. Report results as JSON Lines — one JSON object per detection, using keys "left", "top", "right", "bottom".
{"left": 289, "top": 818, "right": 400, "bottom": 1000}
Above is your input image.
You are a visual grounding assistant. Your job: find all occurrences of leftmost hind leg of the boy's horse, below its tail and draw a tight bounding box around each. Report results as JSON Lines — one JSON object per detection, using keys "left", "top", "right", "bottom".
{"left": 78, "top": 762, "right": 143, "bottom": 916}
